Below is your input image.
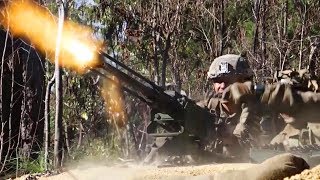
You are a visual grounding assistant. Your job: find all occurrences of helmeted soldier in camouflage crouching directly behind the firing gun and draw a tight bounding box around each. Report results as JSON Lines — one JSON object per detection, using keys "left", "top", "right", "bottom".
{"left": 198, "top": 54, "right": 261, "bottom": 160}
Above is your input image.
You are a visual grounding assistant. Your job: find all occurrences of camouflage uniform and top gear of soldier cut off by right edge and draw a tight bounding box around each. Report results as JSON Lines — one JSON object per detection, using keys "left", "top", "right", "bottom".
{"left": 262, "top": 69, "right": 320, "bottom": 148}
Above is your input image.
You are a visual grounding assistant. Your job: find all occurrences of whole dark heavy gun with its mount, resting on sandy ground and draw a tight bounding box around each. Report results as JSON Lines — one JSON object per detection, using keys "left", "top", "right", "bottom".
{"left": 90, "top": 52, "right": 222, "bottom": 163}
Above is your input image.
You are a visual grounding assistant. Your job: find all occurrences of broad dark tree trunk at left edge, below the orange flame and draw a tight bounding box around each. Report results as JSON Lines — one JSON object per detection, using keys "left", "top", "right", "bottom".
{"left": 0, "top": 30, "right": 45, "bottom": 173}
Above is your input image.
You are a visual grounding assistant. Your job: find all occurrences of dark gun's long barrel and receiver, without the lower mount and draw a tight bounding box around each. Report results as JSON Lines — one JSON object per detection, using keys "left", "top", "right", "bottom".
{"left": 91, "top": 52, "right": 215, "bottom": 140}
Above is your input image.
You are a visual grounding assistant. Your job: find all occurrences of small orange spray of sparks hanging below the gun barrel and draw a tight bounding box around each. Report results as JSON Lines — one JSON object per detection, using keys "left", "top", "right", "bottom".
{"left": 101, "top": 77, "right": 127, "bottom": 128}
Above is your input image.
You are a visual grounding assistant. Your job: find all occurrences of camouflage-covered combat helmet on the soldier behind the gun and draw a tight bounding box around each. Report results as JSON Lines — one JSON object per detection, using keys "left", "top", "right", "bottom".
{"left": 207, "top": 54, "right": 253, "bottom": 80}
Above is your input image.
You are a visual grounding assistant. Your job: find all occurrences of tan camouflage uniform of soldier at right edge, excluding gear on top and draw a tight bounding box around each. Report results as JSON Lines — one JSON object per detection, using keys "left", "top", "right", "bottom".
{"left": 261, "top": 83, "right": 320, "bottom": 148}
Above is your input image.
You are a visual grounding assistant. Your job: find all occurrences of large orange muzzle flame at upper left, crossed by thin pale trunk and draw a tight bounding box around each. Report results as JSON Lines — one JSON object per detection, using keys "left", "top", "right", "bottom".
{"left": 0, "top": 0, "right": 102, "bottom": 73}
